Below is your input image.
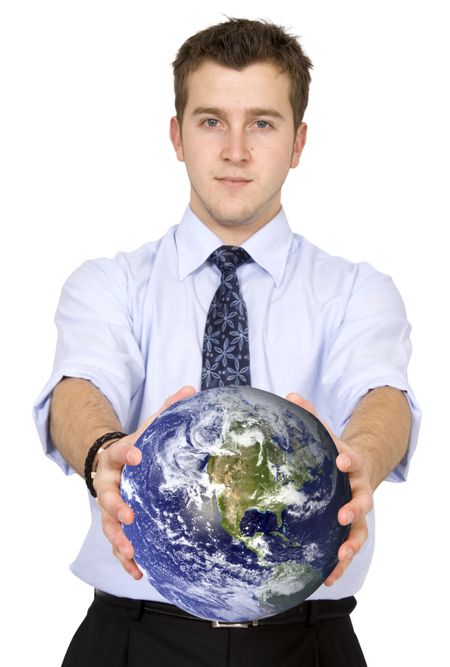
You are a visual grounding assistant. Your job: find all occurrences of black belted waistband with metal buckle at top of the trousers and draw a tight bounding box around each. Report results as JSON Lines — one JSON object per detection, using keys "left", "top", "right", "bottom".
{"left": 95, "top": 589, "right": 356, "bottom": 628}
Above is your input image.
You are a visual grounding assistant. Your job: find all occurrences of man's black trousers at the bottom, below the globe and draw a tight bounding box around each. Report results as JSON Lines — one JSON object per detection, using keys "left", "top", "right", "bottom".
{"left": 62, "top": 594, "right": 367, "bottom": 667}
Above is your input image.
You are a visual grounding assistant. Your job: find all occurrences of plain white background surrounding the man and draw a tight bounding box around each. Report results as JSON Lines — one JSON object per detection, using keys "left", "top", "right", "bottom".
{"left": 0, "top": 0, "right": 450, "bottom": 667}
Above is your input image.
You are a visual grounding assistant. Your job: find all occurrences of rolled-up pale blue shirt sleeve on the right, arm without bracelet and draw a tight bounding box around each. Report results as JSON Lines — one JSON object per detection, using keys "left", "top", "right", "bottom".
{"left": 322, "top": 263, "right": 421, "bottom": 481}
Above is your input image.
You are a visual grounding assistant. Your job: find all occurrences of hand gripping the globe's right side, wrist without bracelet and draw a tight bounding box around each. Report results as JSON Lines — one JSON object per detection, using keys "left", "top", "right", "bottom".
{"left": 286, "top": 393, "right": 373, "bottom": 586}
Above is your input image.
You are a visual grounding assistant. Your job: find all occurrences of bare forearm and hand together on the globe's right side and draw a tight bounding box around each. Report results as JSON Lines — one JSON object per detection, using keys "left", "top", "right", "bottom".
{"left": 287, "top": 387, "right": 411, "bottom": 586}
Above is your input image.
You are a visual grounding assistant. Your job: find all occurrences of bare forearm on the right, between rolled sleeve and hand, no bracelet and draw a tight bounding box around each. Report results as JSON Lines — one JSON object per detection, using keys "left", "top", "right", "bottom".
{"left": 341, "top": 387, "right": 411, "bottom": 490}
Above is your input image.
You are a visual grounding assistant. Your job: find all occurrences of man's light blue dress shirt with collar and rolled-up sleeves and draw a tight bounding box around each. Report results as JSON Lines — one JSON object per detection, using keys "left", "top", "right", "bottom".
{"left": 34, "top": 207, "right": 420, "bottom": 601}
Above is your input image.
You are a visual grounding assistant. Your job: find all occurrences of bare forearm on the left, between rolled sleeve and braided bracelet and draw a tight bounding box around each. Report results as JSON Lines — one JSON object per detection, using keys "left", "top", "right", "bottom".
{"left": 50, "top": 378, "right": 122, "bottom": 476}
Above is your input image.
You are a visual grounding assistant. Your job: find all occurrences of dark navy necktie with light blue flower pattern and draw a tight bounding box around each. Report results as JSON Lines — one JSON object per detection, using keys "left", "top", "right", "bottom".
{"left": 201, "top": 245, "right": 253, "bottom": 389}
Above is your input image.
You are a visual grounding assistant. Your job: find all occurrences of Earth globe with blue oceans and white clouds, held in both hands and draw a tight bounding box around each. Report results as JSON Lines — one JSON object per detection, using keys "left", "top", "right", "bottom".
{"left": 121, "top": 387, "right": 351, "bottom": 622}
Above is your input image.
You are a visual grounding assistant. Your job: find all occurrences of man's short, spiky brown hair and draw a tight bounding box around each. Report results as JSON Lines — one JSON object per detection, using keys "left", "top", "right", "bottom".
{"left": 172, "top": 18, "right": 312, "bottom": 129}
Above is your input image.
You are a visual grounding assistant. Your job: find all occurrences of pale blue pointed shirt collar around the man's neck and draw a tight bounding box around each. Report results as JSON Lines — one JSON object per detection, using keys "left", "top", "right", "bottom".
{"left": 175, "top": 206, "right": 293, "bottom": 287}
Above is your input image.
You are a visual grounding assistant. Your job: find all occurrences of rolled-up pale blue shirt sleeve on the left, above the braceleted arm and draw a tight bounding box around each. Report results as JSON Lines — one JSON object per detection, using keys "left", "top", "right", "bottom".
{"left": 33, "top": 258, "right": 144, "bottom": 474}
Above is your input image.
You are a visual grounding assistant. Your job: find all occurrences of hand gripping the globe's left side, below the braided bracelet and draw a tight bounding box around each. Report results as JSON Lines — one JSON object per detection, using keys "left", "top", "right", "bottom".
{"left": 94, "top": 386, "right": 195, "bottom": 579}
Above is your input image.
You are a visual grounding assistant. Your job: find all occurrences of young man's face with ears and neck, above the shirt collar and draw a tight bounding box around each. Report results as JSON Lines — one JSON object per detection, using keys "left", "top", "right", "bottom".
{"left": 170, "top": 61, "right": 306, "bottom": 238}
